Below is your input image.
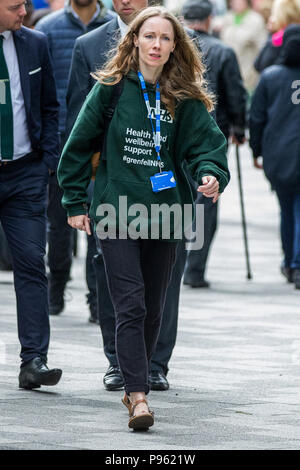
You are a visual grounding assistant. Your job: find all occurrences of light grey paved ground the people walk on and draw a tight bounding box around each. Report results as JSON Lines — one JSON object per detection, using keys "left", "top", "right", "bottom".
{"left": 0, "top": 144, "right": 300, "bottom": 450}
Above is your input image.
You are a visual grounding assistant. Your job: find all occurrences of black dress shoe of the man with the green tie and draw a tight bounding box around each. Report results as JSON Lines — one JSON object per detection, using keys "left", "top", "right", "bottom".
{"left": 19, "top": 357, "right": 62, "bottom": 390}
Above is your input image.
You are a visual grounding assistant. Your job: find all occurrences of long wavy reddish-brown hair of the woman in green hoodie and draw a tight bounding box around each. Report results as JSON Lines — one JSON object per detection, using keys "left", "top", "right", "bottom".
{"left": 93, "top": 7, "right": 214, "bottom": 117}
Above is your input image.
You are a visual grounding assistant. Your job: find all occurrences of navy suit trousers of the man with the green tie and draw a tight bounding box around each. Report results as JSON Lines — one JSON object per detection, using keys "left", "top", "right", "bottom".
{"left": 0, "top": 156, "right": 50, "bottom": 363}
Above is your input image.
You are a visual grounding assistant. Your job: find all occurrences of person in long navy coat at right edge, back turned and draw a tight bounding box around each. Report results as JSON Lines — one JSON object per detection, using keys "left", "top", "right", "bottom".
{"left": 250, "top": 25, "right": 300, "bottom": 289}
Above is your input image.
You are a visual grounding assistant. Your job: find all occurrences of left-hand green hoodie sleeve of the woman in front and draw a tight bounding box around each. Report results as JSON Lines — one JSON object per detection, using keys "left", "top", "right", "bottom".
{"left": 58, "top": 83, "right": 112, "bottom": 216}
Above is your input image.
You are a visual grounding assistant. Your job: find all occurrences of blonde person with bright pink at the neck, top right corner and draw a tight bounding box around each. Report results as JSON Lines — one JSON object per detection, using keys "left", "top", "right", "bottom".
{"left": 254, "top": 0, "right": 300, "bottom": 72}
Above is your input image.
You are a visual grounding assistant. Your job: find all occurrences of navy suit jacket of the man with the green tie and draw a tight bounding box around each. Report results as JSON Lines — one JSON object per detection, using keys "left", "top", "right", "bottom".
{"left": 13, "top": 26, "right": 59, "bottom": 170}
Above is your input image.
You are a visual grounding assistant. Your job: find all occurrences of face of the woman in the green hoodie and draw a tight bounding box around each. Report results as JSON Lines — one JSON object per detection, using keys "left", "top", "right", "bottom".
{"left": 134, "top": 16, "right": 175, "bottom": 74}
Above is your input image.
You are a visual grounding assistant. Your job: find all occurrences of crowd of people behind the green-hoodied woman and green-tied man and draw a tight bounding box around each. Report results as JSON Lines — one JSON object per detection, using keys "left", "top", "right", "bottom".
{"left": 0, "top": 0, "right": 300, "bottom": 396}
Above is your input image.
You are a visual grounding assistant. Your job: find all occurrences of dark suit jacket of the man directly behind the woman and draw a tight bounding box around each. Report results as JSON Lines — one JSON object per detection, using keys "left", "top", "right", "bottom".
{"left": 66, "top": 17, "right": 121, "bottom": 137}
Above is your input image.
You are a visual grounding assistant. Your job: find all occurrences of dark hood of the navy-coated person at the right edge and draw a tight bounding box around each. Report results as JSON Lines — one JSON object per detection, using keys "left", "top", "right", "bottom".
{"left": 279, "top": 24, "right": 300, "bottom": 67}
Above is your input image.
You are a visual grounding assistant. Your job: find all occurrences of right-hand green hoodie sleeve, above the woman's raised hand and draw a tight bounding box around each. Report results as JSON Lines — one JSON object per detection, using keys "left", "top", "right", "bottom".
{"left": 175, "top": 100, "right": 230, "bottom": 192}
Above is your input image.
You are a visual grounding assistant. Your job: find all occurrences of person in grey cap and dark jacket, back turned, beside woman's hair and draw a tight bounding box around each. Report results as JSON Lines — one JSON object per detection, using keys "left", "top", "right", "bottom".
{"left": 182, "top": 0, "right": 247, "bottom": 287}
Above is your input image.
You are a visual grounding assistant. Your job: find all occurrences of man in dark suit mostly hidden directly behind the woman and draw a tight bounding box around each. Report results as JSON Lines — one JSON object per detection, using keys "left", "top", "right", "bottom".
{"left": 67, "top": 0, "right": 200, "bottom": 390}
